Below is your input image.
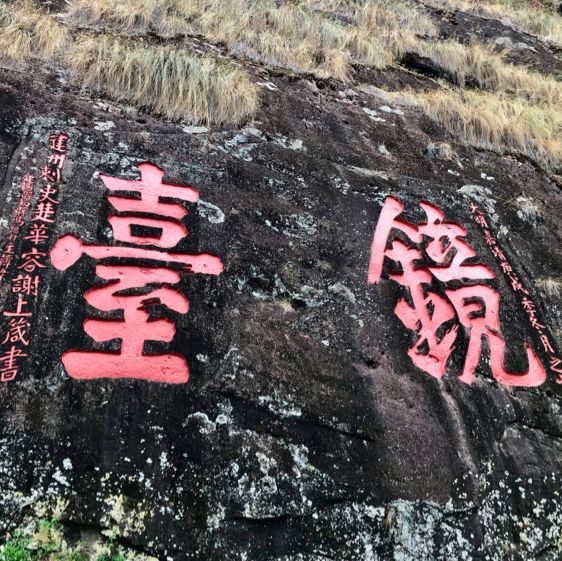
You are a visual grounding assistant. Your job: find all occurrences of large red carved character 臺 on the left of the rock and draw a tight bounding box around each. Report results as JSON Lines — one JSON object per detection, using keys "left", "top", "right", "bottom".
{"left": 51, "top": 163, "right": 223, "bottom": 384}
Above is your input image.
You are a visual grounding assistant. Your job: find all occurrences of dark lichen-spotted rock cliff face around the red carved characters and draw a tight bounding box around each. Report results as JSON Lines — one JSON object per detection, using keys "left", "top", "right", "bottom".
{"left": 0, "top": 1, "right": 562, "bottom": 561}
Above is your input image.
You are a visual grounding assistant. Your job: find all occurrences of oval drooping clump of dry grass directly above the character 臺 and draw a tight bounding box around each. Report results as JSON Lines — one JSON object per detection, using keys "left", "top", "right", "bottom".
{"left": 67, "top": 37, "right": 258, "bottom": 123}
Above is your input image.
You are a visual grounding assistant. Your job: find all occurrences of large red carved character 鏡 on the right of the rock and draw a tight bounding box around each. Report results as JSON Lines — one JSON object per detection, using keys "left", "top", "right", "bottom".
{"left": 368, "top": 197, "right": 546, "bottom": 386}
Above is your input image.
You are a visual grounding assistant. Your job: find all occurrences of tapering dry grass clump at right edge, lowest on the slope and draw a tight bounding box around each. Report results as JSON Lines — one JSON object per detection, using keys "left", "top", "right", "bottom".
{"left": 397, "top": 89, "right": 562, "bottom": 167}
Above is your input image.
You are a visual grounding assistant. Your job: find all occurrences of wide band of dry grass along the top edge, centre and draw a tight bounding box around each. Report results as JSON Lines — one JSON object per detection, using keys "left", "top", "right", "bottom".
{"left": 67, "top": 0, "right": 436, "bottom": 80}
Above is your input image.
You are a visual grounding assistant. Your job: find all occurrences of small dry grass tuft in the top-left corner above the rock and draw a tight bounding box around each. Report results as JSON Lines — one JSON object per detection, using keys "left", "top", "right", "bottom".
{"left": 0, "top": 2, "right": 68, "bottom": 63}
